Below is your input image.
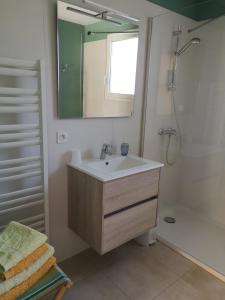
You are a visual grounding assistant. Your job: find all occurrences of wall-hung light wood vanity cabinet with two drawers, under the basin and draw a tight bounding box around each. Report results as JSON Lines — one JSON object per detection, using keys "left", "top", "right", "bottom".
{"left": 68, "top": 167, "right": 160, "bottom": 254}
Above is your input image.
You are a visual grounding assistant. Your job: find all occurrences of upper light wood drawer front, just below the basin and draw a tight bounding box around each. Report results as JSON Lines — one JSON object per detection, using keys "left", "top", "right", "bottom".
{"left": 103, "top": 169, "right": 160, "bottom": 215}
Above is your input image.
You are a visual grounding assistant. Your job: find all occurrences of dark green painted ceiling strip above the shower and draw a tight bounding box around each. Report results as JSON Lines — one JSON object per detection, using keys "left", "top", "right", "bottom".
{"left": 148, "top": 0, "right": 225, "bottom": 21}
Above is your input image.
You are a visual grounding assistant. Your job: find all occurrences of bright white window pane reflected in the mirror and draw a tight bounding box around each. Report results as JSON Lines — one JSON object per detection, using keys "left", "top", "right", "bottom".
{"left": 108, "top": 34, "right": 138, "bottom": 97}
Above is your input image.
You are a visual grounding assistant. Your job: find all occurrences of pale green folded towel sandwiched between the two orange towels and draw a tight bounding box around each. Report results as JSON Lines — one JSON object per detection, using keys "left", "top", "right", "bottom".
{"left": 0, "top": 245, "right": 54, "bottom": 299}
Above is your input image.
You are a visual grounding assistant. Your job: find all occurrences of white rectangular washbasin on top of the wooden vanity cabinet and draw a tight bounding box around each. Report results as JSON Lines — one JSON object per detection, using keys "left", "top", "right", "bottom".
{"left": 69, "top": 155, "right": 163, "bottom": 181}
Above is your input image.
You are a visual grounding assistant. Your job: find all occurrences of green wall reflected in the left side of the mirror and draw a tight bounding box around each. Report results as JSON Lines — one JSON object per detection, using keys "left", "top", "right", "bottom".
{"left": 58, "top": 20, "right": 84, "bottom": 119}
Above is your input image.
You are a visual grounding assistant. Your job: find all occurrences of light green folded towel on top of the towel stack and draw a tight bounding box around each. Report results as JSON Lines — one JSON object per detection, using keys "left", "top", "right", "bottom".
{"left": 0, "top": 222, "right": 47, "bottom": 272}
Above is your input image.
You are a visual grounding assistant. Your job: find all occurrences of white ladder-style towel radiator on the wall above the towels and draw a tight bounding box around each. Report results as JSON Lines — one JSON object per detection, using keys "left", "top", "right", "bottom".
{"left": 0, "top": 58, "right": 49, "bottom": 235}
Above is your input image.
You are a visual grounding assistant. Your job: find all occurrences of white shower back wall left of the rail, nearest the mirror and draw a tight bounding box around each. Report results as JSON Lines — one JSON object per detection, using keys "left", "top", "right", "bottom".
{"left": 144, "top": 13, "right": 194, "bottom": 209}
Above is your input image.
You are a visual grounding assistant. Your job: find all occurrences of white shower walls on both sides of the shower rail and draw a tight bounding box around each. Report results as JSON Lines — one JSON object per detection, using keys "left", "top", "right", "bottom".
{"left": 144, "top": 8, "right": 225, "bottom": 227}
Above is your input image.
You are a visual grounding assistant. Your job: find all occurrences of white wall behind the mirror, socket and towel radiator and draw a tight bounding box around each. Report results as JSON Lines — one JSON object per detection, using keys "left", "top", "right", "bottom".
{"left": 0, "top": 0, "right": 170, "bottom": 260}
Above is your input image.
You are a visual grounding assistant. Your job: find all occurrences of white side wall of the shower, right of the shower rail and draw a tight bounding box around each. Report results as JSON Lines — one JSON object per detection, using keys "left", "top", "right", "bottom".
{"left": 178, "top": 18, "right": 225, "bottom": 226}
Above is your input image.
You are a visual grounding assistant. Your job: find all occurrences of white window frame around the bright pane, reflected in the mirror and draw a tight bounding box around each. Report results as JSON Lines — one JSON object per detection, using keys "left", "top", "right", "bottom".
{"left": 105, "top": 31, "right": 138, "bottom": 101}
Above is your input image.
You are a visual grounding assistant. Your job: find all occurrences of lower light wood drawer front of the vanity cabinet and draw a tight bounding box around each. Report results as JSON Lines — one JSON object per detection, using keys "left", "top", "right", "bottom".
{"left": 102, "top": 199, "right": 157, "bottom": 254}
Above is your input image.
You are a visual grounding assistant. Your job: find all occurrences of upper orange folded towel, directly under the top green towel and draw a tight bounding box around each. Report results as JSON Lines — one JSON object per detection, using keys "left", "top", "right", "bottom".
{"left": 0, "top": 244, "right": 48, "bottom": 283}
